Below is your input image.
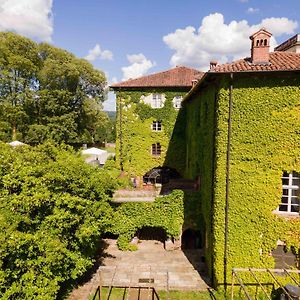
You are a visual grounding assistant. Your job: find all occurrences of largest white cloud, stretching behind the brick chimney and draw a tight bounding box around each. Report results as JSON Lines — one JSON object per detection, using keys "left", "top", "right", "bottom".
{"left": 163, "top": 13, "right": 298, "bottom": 70}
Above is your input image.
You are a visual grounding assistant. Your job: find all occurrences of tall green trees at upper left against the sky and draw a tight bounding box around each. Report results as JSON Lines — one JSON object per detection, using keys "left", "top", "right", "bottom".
{"left": 0, "top": 32, "right": 112, "bottom": 143}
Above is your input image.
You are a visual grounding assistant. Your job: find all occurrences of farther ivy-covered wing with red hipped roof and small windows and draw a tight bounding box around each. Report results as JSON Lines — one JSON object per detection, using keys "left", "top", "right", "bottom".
{"left": 111, "top": 66, "right": 204, "bottom": 184}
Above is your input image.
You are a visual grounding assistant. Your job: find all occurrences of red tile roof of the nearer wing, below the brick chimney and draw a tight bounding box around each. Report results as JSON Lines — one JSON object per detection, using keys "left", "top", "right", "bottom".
{"left": 210, "top": 51, "right": 300, "bottom": 73}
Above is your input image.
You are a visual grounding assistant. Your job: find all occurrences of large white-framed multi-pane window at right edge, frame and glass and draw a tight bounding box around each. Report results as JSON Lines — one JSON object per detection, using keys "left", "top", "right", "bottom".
{"left": 279, "top": 172, "right": 300, "bottom": 214}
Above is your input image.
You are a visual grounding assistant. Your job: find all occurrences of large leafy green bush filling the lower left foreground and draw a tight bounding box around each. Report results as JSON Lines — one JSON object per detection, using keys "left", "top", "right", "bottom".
{"left": 0, "top": 143, "right": 114, "bottom": 300}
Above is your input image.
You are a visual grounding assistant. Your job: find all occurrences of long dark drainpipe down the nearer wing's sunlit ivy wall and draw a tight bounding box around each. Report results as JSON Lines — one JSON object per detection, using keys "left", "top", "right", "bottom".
{"left": 224, "top": 73, "right": 233, "bottom": 292}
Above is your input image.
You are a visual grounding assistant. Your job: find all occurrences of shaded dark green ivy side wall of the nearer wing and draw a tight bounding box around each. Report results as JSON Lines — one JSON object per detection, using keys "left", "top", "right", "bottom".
{"left": 183, "top": 86, "right": 217, "bottom": 282}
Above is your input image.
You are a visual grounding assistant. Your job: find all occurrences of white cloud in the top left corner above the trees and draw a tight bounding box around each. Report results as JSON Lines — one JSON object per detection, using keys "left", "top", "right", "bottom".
{"left": 0, "top": 0, "right": 53, "bottom": 42}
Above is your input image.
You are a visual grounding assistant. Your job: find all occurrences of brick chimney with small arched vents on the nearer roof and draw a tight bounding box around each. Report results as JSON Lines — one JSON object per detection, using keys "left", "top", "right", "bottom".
{"left": 250, "top": 28, "right": 272, "bottom": 64}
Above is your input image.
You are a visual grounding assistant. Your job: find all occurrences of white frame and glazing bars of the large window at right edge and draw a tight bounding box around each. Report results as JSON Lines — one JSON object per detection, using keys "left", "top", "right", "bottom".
{"left": 277, "top": 172, "right": 300, "bottom": 215}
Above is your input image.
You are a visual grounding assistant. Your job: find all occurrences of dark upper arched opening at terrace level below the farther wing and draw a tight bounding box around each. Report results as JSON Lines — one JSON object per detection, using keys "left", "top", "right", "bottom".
{"left": 143, "top": 167, "right": 180, "bottom": 184}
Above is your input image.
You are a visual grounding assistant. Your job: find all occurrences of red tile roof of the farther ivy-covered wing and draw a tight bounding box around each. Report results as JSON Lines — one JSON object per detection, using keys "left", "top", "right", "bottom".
{"left": 110, "top": 66, "right": 204, "bottom": 89}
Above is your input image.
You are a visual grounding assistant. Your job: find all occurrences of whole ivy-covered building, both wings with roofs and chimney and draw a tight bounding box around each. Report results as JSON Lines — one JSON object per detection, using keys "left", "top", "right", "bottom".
{"left": 112, "top": 29, "right": 300, "bottom": 286}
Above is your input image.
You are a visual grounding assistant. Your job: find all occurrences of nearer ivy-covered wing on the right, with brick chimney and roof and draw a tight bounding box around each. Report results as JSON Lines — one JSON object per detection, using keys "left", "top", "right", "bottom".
{"left": 182, "top": 29, "right": 300, "bottom": 285}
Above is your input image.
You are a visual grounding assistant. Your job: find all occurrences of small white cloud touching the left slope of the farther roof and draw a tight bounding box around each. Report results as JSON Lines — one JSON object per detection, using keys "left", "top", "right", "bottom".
{"left": 122, "top": 53, "right": 156, "bottom": 80}
